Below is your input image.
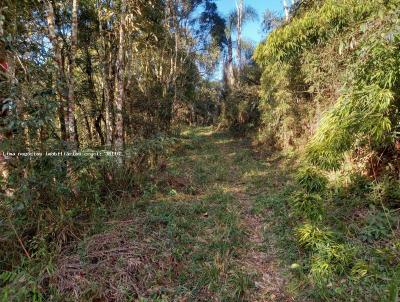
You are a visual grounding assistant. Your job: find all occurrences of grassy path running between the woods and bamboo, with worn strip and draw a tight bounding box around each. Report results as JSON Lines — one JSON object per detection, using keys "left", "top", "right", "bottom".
{"left": 51, "top": 128, "right": 293, "bottom": 301}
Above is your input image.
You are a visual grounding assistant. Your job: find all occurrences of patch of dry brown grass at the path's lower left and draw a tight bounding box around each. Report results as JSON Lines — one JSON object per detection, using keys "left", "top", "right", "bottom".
{"left": 50, "top": 219, "right": 172, "bottom": 301}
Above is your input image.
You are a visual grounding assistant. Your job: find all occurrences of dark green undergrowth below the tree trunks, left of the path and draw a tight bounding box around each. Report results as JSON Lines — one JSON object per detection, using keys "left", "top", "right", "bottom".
{"left": 0, "top": 136, "right": 176, "bottom": 269}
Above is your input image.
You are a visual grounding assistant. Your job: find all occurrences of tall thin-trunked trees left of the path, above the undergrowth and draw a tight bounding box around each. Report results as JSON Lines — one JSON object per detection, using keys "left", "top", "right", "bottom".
{"left": 2, "top": 1, "right": 224, "bottom": 148}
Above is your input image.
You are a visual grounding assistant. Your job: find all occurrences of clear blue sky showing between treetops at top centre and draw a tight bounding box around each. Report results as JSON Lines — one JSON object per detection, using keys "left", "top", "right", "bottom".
{"left": 215, "top": 0, "right": 283, "bottom": 44}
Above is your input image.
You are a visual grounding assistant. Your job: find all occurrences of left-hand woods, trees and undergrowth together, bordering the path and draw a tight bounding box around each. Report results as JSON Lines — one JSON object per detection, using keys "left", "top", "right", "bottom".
{"left": 0, "top": 0, "right": 225, "bottom": 292}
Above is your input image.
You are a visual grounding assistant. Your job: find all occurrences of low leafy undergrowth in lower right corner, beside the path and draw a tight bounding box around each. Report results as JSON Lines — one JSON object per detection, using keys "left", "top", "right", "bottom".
{"left": 256, "top": 156, "right": 400, "bottom": 301}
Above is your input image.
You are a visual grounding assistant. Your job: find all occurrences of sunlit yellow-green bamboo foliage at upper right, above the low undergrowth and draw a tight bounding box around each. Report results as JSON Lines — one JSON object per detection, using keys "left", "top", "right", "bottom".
{"left": 255, "top": 0, "right": 400, "bottom": 169}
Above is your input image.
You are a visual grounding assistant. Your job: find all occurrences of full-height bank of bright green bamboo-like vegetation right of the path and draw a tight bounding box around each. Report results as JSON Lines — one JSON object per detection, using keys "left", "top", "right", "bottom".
{"left": 255, "top": 0, "right": 400, "bottom": 301}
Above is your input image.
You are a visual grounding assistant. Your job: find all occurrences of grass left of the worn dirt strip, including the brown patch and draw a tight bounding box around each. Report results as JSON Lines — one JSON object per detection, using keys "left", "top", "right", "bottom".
{"left": 3, "top": 128, "right": 266, "bottom": 301}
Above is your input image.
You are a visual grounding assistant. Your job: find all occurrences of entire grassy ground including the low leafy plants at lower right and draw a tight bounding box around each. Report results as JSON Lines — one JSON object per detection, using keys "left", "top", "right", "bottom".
{"left": 0, "top": 128, "right": 400, "bottom": 302}
